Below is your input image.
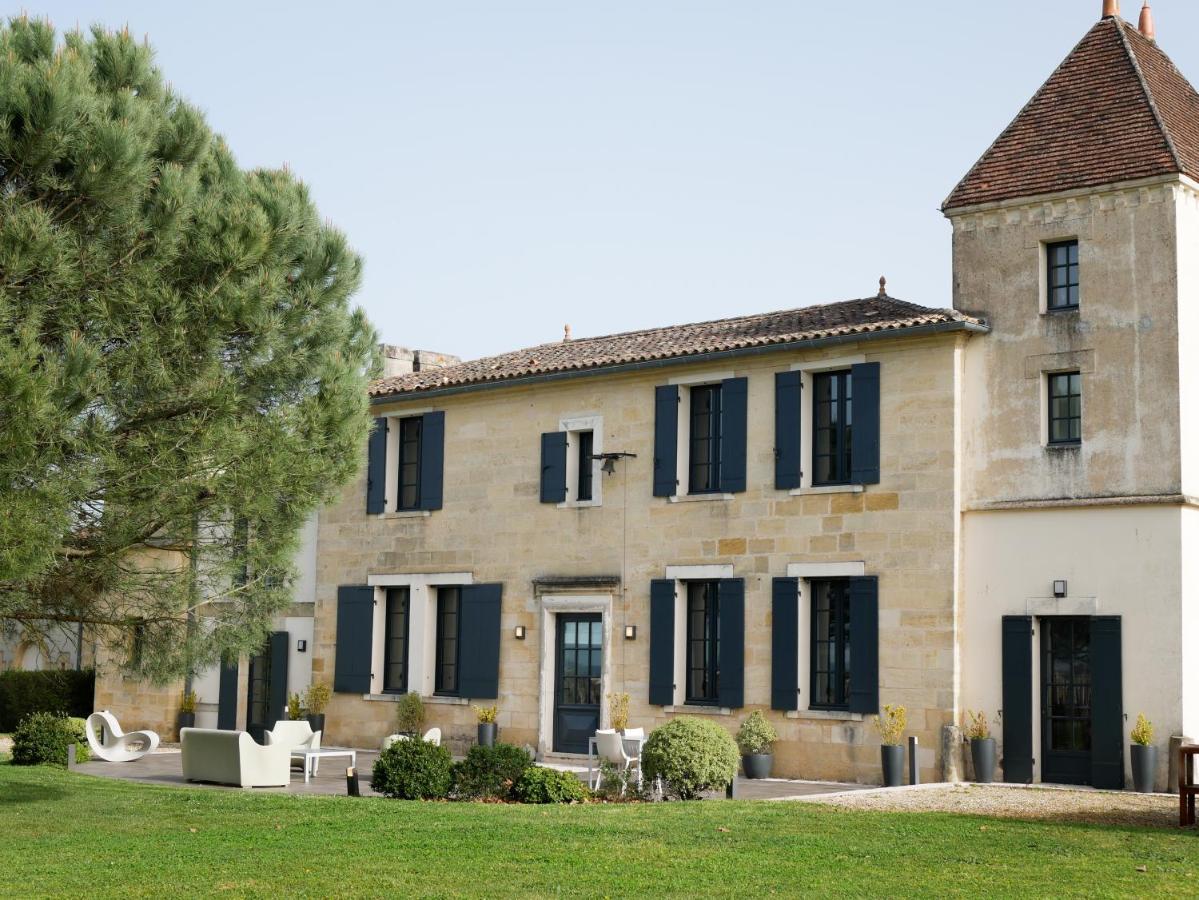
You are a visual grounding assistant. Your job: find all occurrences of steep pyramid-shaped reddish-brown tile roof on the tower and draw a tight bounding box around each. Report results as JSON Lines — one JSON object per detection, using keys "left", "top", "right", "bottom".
{"left": 942, "top": 16, "right": 1199, "bottom": 210}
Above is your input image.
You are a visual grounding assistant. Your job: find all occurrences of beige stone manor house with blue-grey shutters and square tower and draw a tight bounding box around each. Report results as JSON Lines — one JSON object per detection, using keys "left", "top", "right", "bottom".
{"left": 101, "top": 0, "right": 1199, "bottom": 787}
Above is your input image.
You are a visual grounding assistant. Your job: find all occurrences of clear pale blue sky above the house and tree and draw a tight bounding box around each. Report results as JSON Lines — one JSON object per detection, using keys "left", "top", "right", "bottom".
{"left": 18, "top": 0, "right": 1199, "bottom": 357}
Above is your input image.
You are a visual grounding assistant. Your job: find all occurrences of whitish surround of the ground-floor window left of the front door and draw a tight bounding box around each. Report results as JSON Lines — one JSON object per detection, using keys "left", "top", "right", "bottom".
{"left": 367, "top": 572, "right": 475, "bottom": 703}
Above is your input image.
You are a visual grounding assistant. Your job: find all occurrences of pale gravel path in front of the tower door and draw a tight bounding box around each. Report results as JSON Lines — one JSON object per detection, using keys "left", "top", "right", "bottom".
{"left": 803, "top": 785, "right": 1179, "bottom": 828}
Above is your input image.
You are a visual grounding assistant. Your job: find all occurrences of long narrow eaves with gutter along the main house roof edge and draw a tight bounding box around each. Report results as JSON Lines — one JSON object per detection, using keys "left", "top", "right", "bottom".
{"left": 370, "top": 316, "right": 990, "bottom": 406}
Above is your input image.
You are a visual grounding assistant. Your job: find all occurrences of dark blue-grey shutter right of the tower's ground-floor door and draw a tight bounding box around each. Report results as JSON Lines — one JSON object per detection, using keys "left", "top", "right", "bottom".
{"left": 1091, "top": 616, "right": 1125, "bottom": 791}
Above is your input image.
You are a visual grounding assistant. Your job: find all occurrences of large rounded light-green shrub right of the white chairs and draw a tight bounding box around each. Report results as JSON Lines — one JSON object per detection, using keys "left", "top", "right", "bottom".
{"left": 641, "top": 715, "right": 740, "bottom": 801}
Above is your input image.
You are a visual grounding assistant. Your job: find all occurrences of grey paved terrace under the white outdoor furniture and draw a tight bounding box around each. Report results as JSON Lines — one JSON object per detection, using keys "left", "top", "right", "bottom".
{"left": 74, "top": 748, "right": 869, "bottom": 801}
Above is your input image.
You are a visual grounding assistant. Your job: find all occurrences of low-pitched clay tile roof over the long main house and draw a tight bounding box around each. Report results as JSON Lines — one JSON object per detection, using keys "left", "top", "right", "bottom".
{"left": 370, "top": 296, "right": 983, "bottom": 397}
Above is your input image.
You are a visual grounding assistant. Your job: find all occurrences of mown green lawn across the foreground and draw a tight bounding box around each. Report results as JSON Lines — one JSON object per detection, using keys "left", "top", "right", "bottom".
{"left": 0, "top": 763, "right": 1199, "bottom": 898}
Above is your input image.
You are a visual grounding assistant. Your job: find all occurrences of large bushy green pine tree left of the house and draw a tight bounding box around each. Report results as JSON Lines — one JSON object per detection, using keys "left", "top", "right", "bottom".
{"left": 0, "top": 18, "right": 376, "bottom": 677}
